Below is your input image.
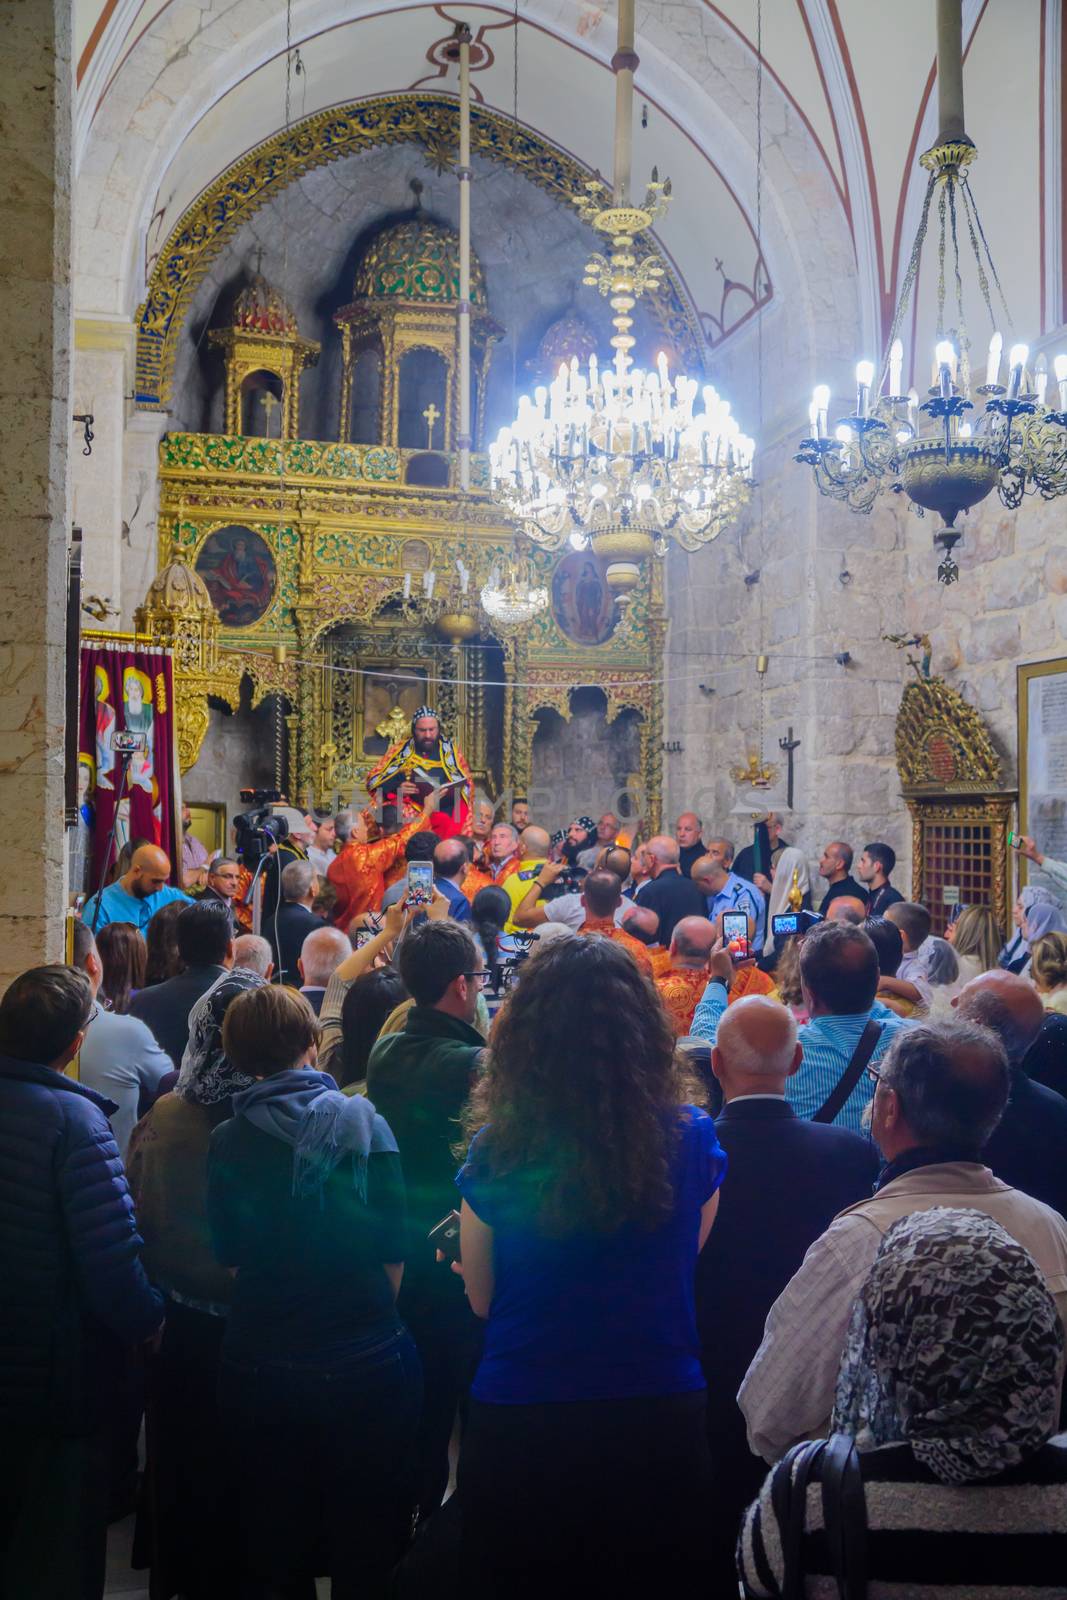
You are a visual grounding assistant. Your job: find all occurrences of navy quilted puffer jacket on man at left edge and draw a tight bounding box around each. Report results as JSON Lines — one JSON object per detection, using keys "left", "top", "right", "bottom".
{"left": 0, "top": 1056, "right": 163, "bottom": 1434}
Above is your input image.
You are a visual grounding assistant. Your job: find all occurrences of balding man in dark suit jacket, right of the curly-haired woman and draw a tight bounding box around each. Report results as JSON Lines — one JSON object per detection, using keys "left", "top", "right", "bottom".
{"left": 697, "top": 992, "right": 878, "bottom": 1594}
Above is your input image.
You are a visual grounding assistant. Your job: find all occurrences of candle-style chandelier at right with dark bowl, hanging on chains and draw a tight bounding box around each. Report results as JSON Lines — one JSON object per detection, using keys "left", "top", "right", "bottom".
{"left": 795, "top": 0, "right": 1067, "bottom": 584}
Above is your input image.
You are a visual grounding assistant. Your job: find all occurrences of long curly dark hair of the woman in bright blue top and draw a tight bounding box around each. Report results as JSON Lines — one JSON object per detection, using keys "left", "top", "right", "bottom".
{"left": 464, "top": 938, "right": 700, "bottom": 1235}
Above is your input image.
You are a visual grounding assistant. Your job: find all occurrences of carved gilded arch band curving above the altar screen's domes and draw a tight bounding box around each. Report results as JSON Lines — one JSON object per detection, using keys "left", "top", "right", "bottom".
{"left": 134, "top": 94, "right": 704, "bottom": 411}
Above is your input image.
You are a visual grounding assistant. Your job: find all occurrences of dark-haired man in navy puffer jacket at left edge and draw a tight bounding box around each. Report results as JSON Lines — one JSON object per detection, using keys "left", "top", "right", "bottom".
{"left": 0, "top": 966, "right": 163, "bottom": 1600}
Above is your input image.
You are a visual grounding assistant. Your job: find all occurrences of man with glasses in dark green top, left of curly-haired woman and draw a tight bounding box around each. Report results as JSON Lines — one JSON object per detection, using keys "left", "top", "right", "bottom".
{"left": 366, "top": 917, "right": 486, "bottom": 1515}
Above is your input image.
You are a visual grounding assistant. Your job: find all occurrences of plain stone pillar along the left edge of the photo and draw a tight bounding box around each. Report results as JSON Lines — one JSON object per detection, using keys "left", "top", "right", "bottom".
{"left": 0, "top": 0, "right": 72, "bottom": 987}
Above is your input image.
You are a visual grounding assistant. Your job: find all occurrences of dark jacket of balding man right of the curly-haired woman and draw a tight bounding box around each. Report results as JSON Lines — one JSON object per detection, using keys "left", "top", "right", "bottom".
{"left": 696, "top": 1099, "right": 878, "bottom": 1539}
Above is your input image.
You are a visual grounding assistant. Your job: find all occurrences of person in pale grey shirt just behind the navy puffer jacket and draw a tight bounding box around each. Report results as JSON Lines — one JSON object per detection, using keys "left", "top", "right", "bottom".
{"left": 72, "top": 907, "right": 173, "bottom": 1162}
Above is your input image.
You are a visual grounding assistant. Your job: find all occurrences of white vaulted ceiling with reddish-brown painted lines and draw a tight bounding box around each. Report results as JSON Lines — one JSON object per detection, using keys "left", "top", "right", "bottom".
{"left": 75, "top": 0, "right": 1064, "bottom": 406}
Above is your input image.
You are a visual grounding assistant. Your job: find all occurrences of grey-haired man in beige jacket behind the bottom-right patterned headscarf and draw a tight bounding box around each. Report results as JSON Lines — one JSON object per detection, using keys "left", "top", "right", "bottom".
{"left": 737, "top": 1021, "right": 1067, "bottom": 1461}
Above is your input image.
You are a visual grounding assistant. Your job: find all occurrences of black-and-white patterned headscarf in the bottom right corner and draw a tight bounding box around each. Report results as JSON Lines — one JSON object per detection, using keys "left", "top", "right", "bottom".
{"left": 833, "top": 1206, "right": 1064, "bottom": 1483}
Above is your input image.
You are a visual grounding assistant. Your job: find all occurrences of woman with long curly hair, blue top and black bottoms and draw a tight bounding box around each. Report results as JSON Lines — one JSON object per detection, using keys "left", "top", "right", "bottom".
{"left": 456, "top": 936, "right": 726, "bottom": 1600}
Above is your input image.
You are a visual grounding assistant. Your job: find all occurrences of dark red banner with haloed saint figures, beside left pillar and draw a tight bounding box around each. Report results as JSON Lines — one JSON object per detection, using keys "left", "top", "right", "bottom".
{"left": 70, "top": 642, "right": 181, "bottom": 893}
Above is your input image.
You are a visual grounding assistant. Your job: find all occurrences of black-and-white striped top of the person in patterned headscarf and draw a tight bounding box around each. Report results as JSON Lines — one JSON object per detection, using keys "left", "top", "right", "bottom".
{"left": 737, "top": 1434, "right": 1067, "bottom": 1600}
